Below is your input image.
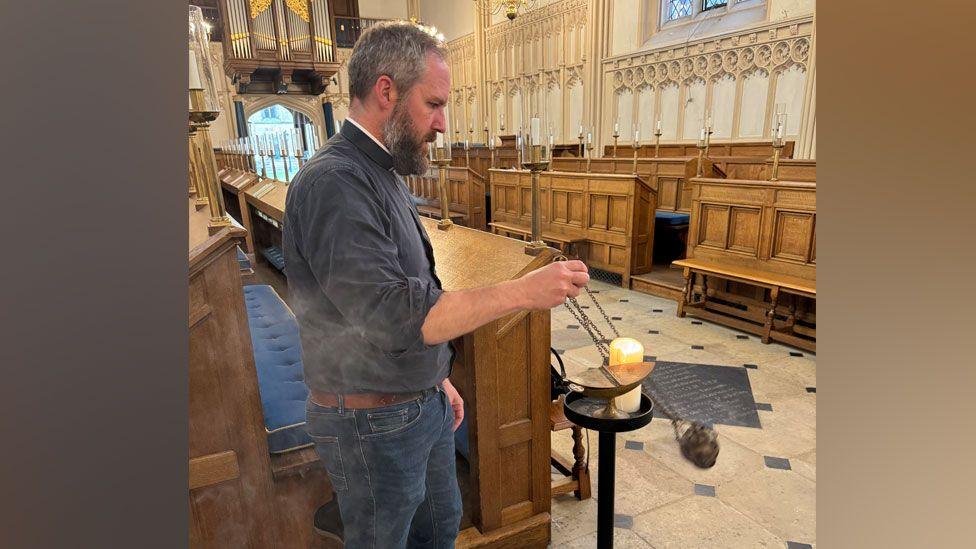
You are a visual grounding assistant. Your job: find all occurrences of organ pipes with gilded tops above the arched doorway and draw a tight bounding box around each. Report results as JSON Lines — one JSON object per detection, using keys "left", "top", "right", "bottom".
{"left": 220, "top": 0, "right": 335, "bottom": 63}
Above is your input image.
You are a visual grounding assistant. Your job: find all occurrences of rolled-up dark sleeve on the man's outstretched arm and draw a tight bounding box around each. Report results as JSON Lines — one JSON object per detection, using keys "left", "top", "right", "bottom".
{"left": 295, "top": 167, "right": 443, "bottom": 357}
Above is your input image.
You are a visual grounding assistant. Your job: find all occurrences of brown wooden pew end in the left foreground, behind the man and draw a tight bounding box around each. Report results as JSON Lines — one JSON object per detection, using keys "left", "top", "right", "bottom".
{"left": 188, "top": 201, "right": 332, "bottom": 549}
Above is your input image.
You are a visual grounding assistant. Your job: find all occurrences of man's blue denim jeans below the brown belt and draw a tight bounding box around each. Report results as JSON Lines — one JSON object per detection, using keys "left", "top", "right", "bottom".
{"left": 306, "top": 388, "right": 461, "bottom": 549}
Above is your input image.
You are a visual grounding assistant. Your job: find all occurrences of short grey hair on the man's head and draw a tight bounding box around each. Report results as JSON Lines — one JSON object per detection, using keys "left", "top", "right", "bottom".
{"left": 349, "top": 21, "right": 447, "bottom": 100}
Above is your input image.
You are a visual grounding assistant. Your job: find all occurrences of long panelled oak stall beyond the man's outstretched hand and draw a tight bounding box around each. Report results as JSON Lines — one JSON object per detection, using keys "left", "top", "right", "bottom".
{"left": 491, "top": 170, "right": 657, "bottom": 288}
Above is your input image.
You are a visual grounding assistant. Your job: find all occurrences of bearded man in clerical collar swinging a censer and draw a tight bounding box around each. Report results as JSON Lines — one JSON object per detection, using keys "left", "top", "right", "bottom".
{"left": 284, "top": 22, "right": 589, "bottom": 549}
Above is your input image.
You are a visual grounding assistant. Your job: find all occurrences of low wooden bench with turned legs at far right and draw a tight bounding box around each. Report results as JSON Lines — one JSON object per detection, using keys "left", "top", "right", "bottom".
{"left": 673, "top": 259, "right": 817, "bottom": 352}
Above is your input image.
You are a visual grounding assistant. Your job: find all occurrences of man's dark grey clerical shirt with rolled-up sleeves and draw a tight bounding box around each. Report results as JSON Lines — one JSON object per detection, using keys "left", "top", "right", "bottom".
{"left": 282, "top": 120, "right": 453, "bottom": 394}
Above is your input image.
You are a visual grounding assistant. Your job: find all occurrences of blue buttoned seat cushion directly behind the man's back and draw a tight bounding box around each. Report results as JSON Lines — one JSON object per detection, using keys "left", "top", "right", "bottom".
{"left": 244, "top": 285, "right": 313, "bottom": 454}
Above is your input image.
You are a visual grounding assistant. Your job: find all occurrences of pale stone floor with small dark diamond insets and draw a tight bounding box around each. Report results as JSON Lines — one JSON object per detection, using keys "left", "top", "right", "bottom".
{"left": 552, "top": 280, "right": 817, "bottom": 549}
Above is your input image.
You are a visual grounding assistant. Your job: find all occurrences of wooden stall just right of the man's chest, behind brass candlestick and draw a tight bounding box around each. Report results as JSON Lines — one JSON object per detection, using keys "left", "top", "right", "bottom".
{"left": 406, "top": 166, "right": 488, "bottom": 231}
